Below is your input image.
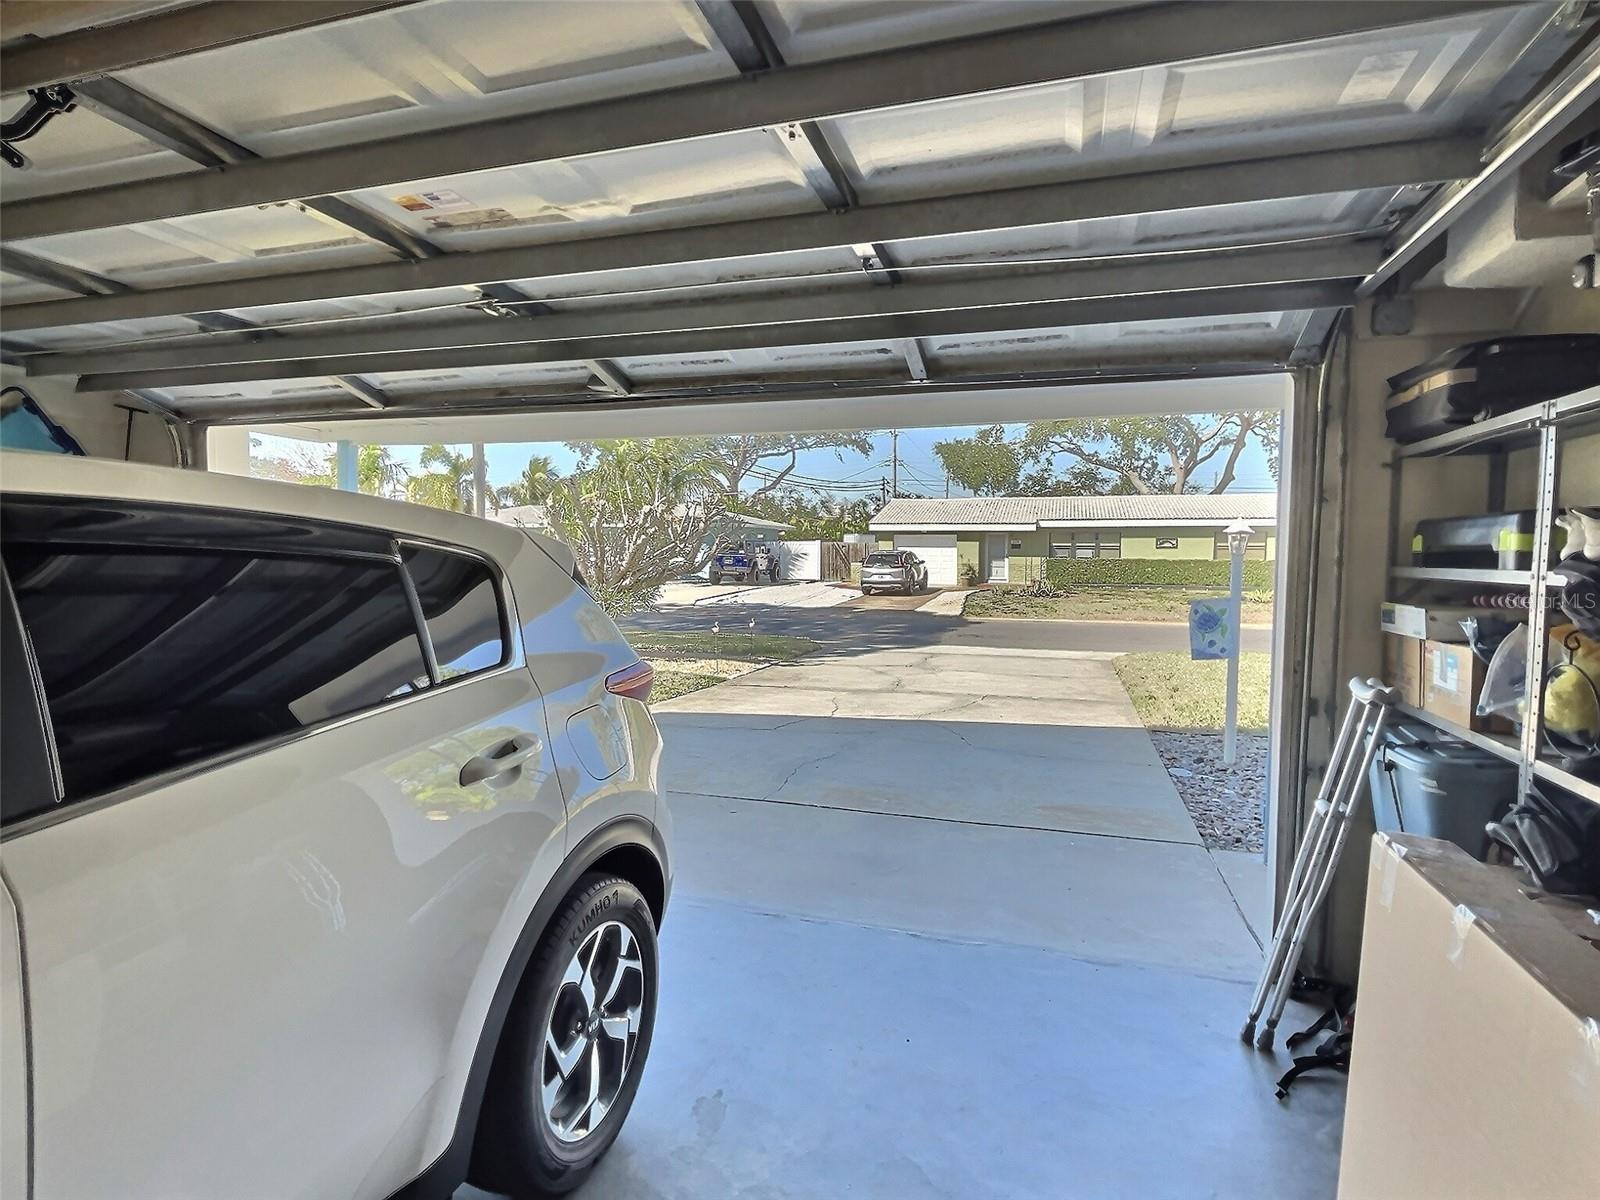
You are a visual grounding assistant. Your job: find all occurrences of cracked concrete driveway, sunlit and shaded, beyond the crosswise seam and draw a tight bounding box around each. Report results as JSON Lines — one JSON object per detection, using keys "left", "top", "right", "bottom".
{"left": 659, "top": 646, "right": 1200, "bottom": 843}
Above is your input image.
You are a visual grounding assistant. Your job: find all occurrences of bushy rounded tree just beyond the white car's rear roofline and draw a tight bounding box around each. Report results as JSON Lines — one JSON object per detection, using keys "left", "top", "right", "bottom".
{"left": 546, "top": 438, "right": 726, "bottom": 613}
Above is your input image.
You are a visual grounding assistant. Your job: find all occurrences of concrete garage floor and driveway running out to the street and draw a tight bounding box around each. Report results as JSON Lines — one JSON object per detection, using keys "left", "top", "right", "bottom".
{"left": 470, "top": 646, "right": 1342, "bottom": 1200}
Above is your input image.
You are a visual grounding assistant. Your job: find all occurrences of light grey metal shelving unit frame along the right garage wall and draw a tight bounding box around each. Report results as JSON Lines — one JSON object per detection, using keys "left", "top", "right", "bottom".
{"left": 1389, "top": 387, "right": 1600, "bottom": 805}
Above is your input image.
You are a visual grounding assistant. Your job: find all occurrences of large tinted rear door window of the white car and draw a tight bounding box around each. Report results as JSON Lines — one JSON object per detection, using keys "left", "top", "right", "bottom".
{"left": 3, "top": 530, "right": 427, "bottom": 800}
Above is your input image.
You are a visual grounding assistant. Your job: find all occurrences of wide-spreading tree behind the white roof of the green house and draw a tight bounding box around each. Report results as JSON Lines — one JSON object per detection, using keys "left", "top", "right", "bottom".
{"left": 1019, "top": 413, "right": 1278, "bottom": 496}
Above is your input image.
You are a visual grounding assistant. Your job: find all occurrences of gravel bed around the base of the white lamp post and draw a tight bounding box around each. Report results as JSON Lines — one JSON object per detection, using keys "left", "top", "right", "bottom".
{"left": 1150, "top": 730, "right": 1267, "bottom": 851}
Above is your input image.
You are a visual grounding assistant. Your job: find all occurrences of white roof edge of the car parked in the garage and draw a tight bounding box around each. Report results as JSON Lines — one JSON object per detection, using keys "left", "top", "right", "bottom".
{"left": 0, "top": 450, "right": 537, "bottom": 562}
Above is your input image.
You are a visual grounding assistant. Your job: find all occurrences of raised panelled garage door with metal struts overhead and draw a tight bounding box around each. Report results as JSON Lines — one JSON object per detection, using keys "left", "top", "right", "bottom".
{"left": 0, "top": 0, "right": 1594, "bottom": 421}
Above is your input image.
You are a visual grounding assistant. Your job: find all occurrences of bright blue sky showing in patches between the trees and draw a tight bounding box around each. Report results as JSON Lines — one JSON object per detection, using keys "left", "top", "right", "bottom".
{"left": 254, "top": 426, "right": 1275, "bottom": 496}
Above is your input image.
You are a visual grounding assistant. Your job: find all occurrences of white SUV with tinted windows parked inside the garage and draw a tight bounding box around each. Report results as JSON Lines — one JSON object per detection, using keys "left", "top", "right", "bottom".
{"left": 0, "top": 453, "right": 672, "bottom": 1200}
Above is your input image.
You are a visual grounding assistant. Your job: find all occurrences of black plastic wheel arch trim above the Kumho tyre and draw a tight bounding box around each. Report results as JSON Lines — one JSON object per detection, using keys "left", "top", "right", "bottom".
{"left": 389, "top": 816, "right": 670, "bottom": 1200}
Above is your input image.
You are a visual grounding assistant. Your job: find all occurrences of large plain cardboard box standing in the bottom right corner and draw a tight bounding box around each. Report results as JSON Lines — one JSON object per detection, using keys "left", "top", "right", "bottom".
{"left": 1339, "top": 834, "right": 1600, "bottom": 1200}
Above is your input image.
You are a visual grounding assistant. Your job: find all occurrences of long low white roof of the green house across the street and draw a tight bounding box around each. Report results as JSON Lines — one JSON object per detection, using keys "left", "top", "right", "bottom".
{"left": 869, "top": 491, "right": 1278, "bottom": 533}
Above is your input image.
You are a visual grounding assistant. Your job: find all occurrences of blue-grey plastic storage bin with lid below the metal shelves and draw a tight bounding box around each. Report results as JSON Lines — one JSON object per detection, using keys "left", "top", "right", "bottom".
{"left": 1368, "top": 722, "right": 1517, "bottom": 859}
